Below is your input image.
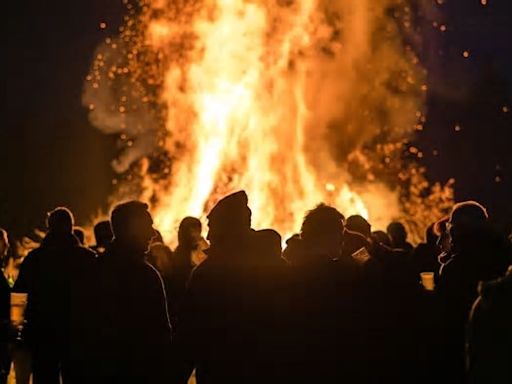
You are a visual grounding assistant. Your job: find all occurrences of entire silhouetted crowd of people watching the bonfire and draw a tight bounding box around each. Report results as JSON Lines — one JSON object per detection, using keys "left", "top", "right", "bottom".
{"left": 0, "top": 191, "right": 512, "bottom": 384}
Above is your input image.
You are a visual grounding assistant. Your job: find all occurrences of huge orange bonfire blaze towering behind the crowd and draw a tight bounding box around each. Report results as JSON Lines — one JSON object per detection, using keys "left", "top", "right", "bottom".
{"left": 84, "top": 0, "right": 432, "bottom": 242}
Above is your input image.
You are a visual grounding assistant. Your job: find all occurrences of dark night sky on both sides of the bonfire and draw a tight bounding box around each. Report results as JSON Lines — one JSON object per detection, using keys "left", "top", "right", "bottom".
{"left": 0, "top": 0, "right": 512, "bottom": 235}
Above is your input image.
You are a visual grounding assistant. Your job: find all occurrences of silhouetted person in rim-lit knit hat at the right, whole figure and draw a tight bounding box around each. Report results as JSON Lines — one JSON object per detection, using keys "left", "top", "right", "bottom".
{"left": 437, "top": 201, "right": 510, "bottom": 382}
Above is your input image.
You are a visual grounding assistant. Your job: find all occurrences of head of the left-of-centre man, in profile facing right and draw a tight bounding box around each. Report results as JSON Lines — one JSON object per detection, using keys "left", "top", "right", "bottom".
{"left": 110, "top": 200, "right": 155, "bottom": 253}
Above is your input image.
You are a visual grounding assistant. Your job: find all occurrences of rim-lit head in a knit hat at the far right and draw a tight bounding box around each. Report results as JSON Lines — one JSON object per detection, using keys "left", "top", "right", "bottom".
{"left": 447, "top": 201, "right": 489, "bottom": 245}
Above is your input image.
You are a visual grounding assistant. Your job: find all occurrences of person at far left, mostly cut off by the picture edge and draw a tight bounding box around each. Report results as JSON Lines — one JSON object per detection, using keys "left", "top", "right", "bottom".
{"left": 0, "top": 228, "right": 11, "bottom": 384}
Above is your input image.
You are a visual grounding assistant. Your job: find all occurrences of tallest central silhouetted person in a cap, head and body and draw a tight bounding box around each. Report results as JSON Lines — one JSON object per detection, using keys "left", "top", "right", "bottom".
{"left": 175, "top": 191, "right": 284, "bottom": 384}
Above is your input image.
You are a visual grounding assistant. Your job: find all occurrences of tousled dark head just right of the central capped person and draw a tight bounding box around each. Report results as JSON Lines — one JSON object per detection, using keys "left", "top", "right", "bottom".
{"left": 301, "top": 204, "right": 345, "bottom": 250}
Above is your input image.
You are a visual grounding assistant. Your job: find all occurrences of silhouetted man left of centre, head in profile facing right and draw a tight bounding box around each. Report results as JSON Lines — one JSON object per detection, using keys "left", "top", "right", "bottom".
{"left": 90, "top": 201, "right": 171, "bottom": 383}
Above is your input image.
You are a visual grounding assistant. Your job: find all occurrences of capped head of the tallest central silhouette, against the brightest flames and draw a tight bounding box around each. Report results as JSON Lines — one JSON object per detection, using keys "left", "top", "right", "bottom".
{"left": 208, "top": 191, "right": 251, "bottom": 245}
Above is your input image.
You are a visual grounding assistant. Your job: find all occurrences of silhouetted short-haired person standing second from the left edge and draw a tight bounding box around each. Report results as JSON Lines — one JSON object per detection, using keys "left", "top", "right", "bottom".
{"left": 13, "top": 208, "right": 95, "bottom": 384}
